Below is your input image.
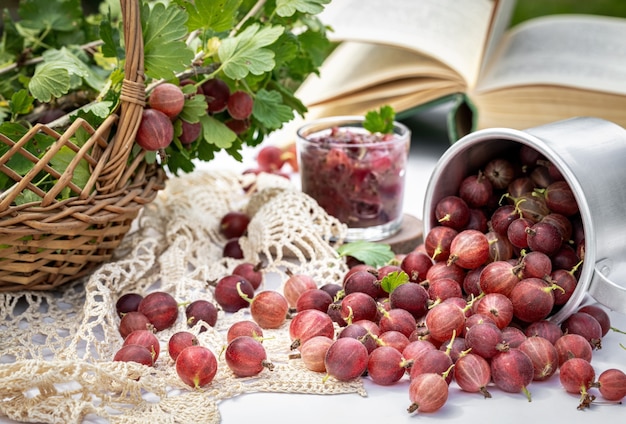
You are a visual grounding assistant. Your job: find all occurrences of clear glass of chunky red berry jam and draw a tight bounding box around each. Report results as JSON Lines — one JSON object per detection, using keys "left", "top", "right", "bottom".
{"left": 296, "top": 116, "right": 411, "bottom": 241}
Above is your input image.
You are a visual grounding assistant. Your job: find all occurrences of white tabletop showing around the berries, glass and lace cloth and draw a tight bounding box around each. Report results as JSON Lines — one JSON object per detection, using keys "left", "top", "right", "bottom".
{"left": 0, "top": 103, "right": 626, "bottom": 424}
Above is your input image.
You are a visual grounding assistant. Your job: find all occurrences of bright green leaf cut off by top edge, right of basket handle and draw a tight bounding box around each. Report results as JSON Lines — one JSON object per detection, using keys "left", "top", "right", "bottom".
{"left": 181, "top": 0, "right": 241, "bottom": 32}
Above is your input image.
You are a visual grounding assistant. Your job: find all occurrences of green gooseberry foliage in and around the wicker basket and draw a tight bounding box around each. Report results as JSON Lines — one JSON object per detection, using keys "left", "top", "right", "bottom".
{"left": 0, "top": 0, "right": 332, "bottom": 202}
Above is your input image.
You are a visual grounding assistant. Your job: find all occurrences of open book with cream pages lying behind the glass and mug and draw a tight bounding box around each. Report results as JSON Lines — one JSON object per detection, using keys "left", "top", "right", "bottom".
{"left": 297, "top": 0, "right": 626, "bottom": 140}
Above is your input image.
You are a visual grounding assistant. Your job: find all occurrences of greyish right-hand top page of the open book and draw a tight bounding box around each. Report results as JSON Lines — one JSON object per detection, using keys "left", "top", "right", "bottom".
{"left": 476, "top": 15, "right": 626, "bottom": 95}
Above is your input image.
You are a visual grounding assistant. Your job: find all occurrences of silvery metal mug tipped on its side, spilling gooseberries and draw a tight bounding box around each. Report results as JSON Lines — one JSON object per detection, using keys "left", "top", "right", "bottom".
{"left": 423, "top": 117, "right": 626, "bottom": 323}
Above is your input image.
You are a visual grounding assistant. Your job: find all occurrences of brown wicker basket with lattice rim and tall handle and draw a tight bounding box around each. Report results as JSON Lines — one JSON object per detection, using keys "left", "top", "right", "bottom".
{"left": 0, "top": 0, "right": 166, "bottom": 291}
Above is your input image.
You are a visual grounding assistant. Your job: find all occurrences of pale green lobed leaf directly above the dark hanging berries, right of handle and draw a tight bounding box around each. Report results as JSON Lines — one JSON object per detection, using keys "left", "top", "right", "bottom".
{"left": 218, "top": 24, "right": 284, "bottom": 80}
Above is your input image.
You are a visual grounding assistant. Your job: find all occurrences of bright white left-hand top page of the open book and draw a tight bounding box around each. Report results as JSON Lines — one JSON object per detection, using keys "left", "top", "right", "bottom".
{"left": 319, "top": 0, "right": 496, "bottom": 85}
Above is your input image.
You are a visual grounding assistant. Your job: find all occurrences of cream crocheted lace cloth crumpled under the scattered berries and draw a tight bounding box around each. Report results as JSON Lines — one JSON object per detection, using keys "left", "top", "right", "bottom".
{"left": 0, "top": 171, "right": 366, "bottom": 423}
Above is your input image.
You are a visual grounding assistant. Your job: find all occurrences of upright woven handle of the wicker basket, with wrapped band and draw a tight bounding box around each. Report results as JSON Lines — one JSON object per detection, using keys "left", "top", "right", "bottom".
{"left": 99, "top": 0, "right": 145, "bottom": 191}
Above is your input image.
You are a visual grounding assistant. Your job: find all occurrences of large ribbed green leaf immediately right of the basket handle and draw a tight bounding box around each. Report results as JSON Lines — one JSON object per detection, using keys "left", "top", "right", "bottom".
{"left": 141, "top": 3, "right": 194, "bottom": 80}
